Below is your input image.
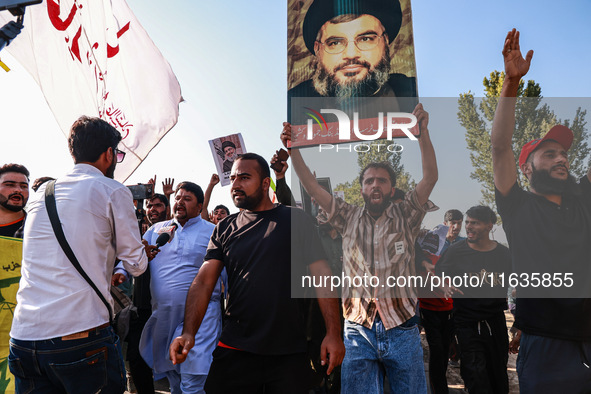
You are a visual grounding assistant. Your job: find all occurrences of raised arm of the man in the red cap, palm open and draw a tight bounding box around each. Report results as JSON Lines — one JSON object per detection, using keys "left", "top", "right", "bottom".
{"left": 491, "top": 29, "right": 534, "bottom": 196}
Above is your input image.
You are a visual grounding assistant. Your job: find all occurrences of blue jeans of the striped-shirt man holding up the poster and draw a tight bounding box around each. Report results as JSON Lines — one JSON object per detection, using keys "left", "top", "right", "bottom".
{"left": 341, "top": 318, "right": 427, "bottom": 394}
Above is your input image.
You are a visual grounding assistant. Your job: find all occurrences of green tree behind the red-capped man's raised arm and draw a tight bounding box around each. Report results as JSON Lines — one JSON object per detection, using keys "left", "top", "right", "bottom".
{"left": 458, "top": 71, "right": 591, "bottom": 207}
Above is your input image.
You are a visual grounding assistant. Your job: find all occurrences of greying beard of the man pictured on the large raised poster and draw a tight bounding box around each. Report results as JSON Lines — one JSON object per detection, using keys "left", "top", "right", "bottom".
{"left": 312, "top": 45, "right": 390, "bottom": 98}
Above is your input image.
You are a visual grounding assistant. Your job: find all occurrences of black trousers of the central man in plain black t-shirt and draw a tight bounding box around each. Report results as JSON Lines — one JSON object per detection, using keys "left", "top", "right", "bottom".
{"left": 205, "top": 346, "right": 310, "bottom": 394}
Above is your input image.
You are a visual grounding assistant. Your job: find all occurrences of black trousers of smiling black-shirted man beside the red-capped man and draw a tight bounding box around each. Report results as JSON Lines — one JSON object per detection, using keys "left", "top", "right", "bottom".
{"left": 456, "top": 312, "right": 509, "bottom": 394}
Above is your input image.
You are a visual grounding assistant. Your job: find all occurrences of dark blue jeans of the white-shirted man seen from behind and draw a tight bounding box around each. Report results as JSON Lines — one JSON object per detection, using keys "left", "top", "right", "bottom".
{"left": 8, "top": 327, "right": 126, "bottom": 394}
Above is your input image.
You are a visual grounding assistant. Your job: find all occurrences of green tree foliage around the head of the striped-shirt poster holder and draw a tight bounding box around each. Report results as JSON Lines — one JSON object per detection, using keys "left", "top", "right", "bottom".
{"left": 334, "top": 141, "right": 416, "bottom": 206}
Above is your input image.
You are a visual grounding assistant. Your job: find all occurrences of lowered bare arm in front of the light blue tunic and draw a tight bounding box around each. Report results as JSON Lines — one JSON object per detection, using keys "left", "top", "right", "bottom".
{"left": 169, "top": 260, "right": 224, "bottom": 364}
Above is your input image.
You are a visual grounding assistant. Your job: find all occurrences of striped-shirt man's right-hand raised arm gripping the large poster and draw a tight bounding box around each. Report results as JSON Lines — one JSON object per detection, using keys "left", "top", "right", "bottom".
{"left": 412, "top": 103, "right": 439, "bottom": 205}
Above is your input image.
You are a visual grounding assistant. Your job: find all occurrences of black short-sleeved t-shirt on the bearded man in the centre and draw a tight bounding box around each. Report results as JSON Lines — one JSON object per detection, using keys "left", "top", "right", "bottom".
{"left": 205, "top": 205, "right": 326, "bottom": 355}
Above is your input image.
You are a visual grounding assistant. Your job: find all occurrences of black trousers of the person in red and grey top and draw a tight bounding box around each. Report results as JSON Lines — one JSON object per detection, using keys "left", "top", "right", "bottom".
{"left": 420, "top": 308, "right": 453, "bottom": 394}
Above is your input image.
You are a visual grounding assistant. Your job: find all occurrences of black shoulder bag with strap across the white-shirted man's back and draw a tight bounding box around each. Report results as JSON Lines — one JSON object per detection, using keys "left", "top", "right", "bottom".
{"left": 45, "top": 180, "right": 137, "bottom": 340}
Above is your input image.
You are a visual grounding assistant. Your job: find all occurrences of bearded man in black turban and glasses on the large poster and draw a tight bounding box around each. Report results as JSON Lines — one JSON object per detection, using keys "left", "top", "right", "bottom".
{"left": 288, "top": 0, "right": 417, "bottom": 100}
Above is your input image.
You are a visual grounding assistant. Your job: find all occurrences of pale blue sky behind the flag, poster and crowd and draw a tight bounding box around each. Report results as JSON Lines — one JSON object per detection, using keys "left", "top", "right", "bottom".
{"left": 0, "top": 0, "right": 591, "bottom": 240}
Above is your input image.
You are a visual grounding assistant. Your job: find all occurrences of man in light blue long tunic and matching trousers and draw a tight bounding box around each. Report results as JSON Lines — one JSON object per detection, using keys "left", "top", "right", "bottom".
{"left": 139, "top": 182, "right": 222, "bottom": 393}
